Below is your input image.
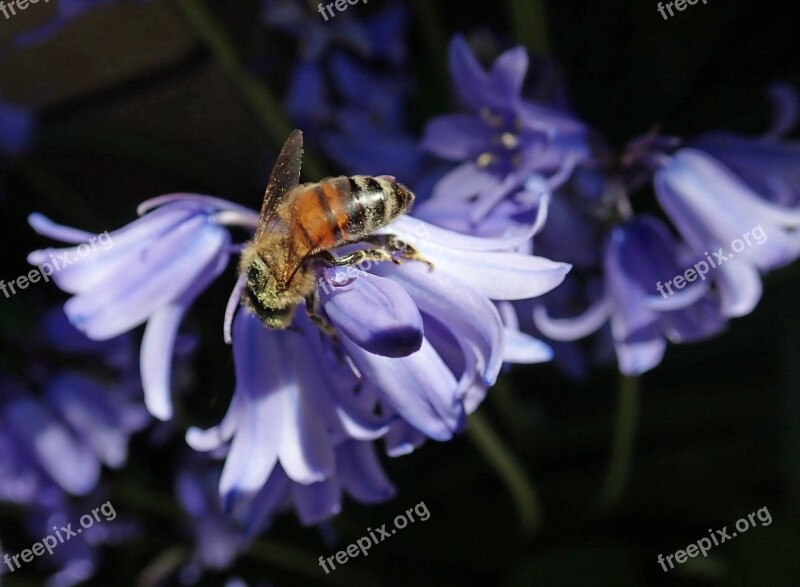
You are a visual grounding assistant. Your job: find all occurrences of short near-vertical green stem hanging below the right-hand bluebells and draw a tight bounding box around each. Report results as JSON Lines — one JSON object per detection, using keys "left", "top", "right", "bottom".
{"left": 600, "top": 375, "right": 639, "bottom": 512}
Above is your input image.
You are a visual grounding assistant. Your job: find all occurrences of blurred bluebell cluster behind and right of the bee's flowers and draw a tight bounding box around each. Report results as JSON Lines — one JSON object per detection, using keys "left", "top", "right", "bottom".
{"left": 419, "top": 38, "right": 800, "bottom": 375}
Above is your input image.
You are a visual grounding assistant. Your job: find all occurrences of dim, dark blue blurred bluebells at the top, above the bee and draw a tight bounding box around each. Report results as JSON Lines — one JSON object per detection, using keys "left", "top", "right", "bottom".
{"left": 263, "top": 0, "right": 422, "bottom": 182}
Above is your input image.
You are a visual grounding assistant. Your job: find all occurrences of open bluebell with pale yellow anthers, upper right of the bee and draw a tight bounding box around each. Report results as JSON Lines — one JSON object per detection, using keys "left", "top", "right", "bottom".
{"left": 422, "top": 37, "right": 590, "bottom": 224}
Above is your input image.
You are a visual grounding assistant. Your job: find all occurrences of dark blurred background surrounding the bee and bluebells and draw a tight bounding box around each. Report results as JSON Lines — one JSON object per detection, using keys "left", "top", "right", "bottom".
{"left": 0, "top": 0, "right": 800, "bottom": 587}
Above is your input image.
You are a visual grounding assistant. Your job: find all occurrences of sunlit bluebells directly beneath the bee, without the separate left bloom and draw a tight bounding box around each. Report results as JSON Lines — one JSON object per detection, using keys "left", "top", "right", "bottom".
{"left": 187, "top": 211, "right": 569, "bottom": 510}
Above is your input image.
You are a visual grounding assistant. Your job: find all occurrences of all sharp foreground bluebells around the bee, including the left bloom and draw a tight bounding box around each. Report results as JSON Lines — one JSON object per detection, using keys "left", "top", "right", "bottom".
{"left": 30, "top": 176, "right": 569, "bottom": 523}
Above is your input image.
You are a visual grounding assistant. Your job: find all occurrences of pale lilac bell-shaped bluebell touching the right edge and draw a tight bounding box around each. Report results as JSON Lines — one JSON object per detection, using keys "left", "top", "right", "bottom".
{"left": 654, "top": 149, "right": 800, "bottom": 316}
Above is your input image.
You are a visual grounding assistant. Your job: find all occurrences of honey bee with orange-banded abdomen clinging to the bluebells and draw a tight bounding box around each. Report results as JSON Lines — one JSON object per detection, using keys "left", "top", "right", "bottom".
{"left": 239, "top": 130, "right": 430, "bottom": 330}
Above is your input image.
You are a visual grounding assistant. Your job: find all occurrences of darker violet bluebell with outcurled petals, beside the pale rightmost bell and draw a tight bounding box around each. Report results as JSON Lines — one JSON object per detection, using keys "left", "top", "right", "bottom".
{"left": 535, "top": 215, "right": 724, "bottom": 375}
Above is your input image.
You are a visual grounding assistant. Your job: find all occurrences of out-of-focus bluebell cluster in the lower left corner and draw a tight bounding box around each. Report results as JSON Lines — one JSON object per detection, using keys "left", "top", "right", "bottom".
{"left": 0, "top": 310, "right": 145, "bottom": 587}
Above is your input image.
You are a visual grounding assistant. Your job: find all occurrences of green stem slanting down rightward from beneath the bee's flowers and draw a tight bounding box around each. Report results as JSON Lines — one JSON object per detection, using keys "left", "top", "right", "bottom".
{"left": 467, "top": 412, "right": 541, "bottom": 536}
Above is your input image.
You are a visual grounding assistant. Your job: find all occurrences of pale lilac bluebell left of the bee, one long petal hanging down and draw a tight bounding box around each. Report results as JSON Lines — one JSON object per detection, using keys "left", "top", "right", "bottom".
{"left": 28, "top": 195, "right": 241, "bottom": 420}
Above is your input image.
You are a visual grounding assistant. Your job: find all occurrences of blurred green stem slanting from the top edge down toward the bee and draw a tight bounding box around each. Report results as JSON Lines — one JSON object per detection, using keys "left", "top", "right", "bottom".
{"left": 176, "top": 0, "right": 326, "bottom": 177}
